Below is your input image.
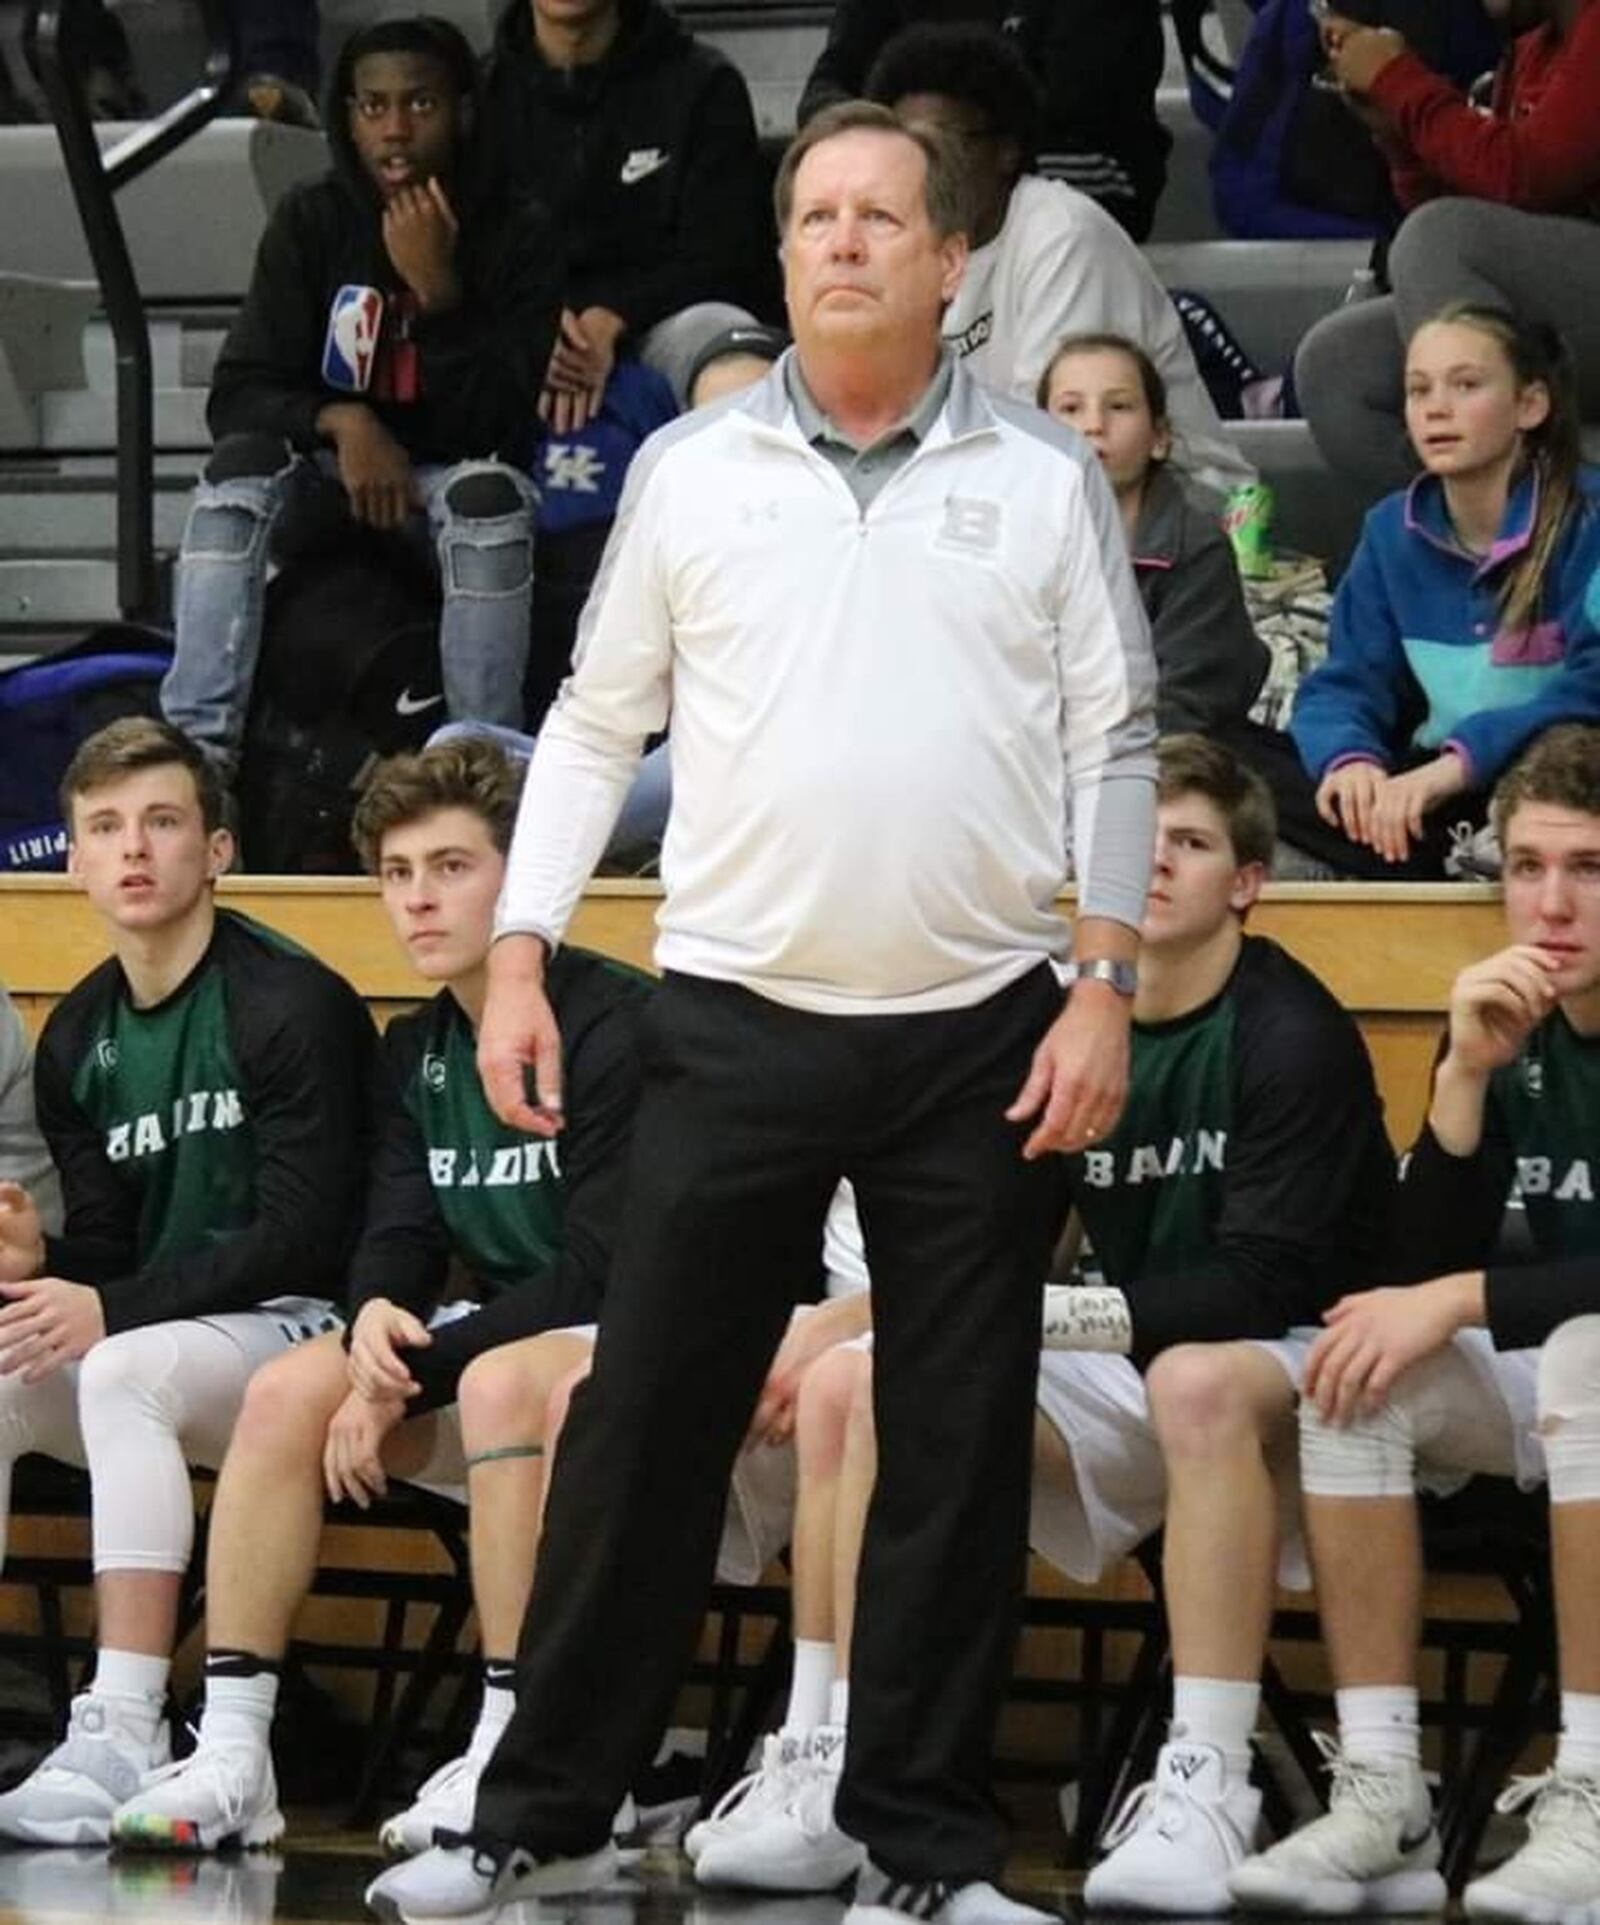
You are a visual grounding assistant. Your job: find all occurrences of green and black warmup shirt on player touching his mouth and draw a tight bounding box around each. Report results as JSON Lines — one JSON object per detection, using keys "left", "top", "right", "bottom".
{"left": 1398, "top": 1009, "right": 1600, "bottom": 1349}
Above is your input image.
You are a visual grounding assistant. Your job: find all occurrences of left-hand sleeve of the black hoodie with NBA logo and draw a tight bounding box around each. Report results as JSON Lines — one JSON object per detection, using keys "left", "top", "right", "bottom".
{"left": 206, "top": 181, "right": 337, "bottom": 452}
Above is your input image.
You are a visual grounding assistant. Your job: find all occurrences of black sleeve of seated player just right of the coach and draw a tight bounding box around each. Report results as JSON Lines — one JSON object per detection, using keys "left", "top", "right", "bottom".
{"left": 1126, "top": 945, "right": 1394, "bottom": 1363}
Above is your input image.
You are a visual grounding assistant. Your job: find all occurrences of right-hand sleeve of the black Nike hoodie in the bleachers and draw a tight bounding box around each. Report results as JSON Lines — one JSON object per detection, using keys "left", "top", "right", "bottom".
{"left": 572, "top": 48, "right": 778, "bottom": 337}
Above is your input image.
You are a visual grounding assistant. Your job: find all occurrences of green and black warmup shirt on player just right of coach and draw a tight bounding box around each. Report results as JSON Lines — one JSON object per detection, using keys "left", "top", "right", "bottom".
{"left": 1069, "top": 936, "right": 1394, "bottom": 1363}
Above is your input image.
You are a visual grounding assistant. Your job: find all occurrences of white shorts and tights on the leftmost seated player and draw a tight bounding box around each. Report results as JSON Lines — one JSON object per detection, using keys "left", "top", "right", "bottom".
{"left": 0, "top": 1311, "right": 315, "bottom": 1571}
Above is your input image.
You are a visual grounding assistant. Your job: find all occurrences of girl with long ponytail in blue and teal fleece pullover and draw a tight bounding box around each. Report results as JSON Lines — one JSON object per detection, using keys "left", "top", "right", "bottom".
{"left": 1275, "top": 306, "right": 1600, "bottom": 878}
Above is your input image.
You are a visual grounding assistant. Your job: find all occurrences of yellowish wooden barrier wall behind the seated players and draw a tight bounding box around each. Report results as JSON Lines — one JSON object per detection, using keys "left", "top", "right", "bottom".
{"left": 0, "top": 876, "right": 1502, "bottom": 1145}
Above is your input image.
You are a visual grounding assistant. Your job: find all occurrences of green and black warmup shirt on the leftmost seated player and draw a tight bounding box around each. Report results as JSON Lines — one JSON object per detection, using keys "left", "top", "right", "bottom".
{"left": 35, "top": 911, "right": 374, "bottom": 1332}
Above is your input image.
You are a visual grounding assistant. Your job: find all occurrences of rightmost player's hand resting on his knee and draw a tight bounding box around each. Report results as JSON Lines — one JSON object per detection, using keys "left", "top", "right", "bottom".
{"left": 1303, "top": 1271, "right": 1483, "bottom": 1425}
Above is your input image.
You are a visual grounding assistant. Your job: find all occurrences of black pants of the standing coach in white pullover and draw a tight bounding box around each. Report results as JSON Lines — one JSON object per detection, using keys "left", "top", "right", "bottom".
{"left": 474, "top": 968, "right": 1063, "bottom": 1877}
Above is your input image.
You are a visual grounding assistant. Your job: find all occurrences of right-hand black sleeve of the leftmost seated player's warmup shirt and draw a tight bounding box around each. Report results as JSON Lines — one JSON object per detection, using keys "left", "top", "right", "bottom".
{"left": 100, "top": 957, "right": 374, "bottom": 1334}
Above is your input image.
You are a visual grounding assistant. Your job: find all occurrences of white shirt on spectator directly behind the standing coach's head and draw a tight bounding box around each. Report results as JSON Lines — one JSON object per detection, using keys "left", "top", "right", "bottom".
{"left": 943, "top": 173, "right": 1255, "bottom": 493}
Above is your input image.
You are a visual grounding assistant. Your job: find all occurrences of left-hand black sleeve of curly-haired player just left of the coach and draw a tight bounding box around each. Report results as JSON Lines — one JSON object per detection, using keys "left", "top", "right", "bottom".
{"left": 348, "top": 1005, "right": 451, "bottom": 1322}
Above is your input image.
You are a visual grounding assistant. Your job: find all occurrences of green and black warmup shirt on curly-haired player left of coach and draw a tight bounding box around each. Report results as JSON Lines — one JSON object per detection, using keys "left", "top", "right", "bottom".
{"left": 350, "top": 947, "right": 653, "bottom": 1413}
